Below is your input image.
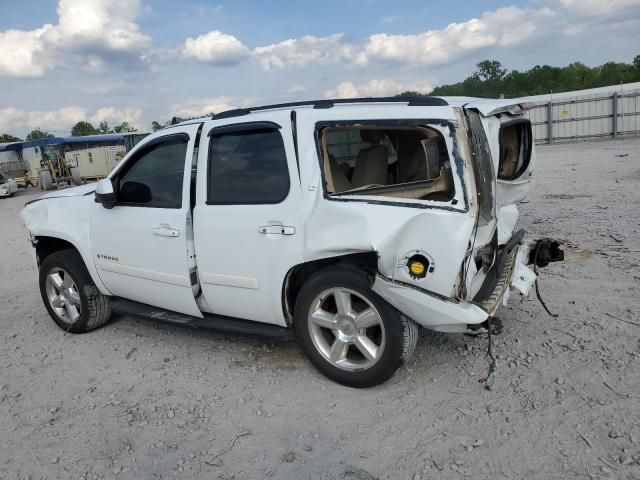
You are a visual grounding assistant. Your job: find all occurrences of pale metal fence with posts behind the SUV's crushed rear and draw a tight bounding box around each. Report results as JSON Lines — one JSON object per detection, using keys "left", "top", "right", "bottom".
{"left": 527, "top": 89, "right": 640, "bottom": 143}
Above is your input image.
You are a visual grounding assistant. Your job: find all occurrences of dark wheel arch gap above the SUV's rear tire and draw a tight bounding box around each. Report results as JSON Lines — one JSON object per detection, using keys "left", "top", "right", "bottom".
{"left": 282, "top": 251, "right": 378, "bottom": 325}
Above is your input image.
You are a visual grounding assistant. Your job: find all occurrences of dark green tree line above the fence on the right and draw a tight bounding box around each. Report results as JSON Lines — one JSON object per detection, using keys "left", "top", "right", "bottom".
{"left": 400, "top": 55, "right": 640, "bottom": 98}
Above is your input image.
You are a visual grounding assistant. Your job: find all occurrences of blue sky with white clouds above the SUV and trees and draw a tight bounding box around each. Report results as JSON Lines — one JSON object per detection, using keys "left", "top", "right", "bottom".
{"left": 0, "top": 0, "right": 640, "bottom": 137}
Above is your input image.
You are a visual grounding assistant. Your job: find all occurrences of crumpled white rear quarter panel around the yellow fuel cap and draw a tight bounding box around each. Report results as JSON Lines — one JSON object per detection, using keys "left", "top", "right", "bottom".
{"left": 304, "top": 199, "right": 473, "bottom": 297}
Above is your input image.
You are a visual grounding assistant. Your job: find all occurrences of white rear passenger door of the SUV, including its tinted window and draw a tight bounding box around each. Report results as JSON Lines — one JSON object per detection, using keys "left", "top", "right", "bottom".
{"left": 194, "top": 111, "right": 303, "bottom": 325}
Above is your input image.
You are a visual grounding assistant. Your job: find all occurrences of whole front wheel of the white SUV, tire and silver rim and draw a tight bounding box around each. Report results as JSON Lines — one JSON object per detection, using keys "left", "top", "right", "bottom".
{"left": 40, "top": 250, "right": 111, "bottom": 333}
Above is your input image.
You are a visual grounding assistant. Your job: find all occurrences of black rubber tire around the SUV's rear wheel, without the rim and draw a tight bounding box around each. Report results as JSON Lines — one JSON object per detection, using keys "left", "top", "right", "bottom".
{"left": 294, "top": 267, "right": 418, "bottom": 388}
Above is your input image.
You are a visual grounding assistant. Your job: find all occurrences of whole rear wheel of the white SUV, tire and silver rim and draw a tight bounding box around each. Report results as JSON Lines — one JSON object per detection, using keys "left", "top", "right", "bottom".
{"left": 294, "top": 267, "right": 418, "bottom": 388}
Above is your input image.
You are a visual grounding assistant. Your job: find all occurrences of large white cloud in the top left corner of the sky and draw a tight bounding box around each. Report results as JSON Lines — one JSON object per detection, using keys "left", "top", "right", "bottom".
{"left": 0, "top": 0, "right": 151, "bottom": 77}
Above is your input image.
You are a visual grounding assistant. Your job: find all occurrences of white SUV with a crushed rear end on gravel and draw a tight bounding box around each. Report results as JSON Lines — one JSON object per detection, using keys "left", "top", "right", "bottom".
{"left": 21, "top": 97, "right": 562, "bottom": 387}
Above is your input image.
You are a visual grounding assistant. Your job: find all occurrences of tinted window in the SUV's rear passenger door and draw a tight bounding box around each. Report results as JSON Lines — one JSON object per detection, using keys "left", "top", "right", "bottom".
{"left": 207, "top": 129, "right": 290, "bottom": 205}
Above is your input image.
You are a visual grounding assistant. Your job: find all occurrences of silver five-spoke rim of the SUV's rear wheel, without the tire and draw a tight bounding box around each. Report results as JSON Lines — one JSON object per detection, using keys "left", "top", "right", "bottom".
{"left": 308, "top": 288, "right": 385, "bottom": 371}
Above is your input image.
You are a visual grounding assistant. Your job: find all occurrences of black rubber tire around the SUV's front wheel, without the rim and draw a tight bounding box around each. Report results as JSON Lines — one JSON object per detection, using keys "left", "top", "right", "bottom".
{"left": 39, "top": 249, "right": 111, "bottom": 333}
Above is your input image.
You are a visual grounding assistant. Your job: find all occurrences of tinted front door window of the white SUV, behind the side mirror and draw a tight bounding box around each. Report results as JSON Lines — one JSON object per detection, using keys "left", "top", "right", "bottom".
{"left": 117, "top": 136, "right": 188, "bottom": 208}
